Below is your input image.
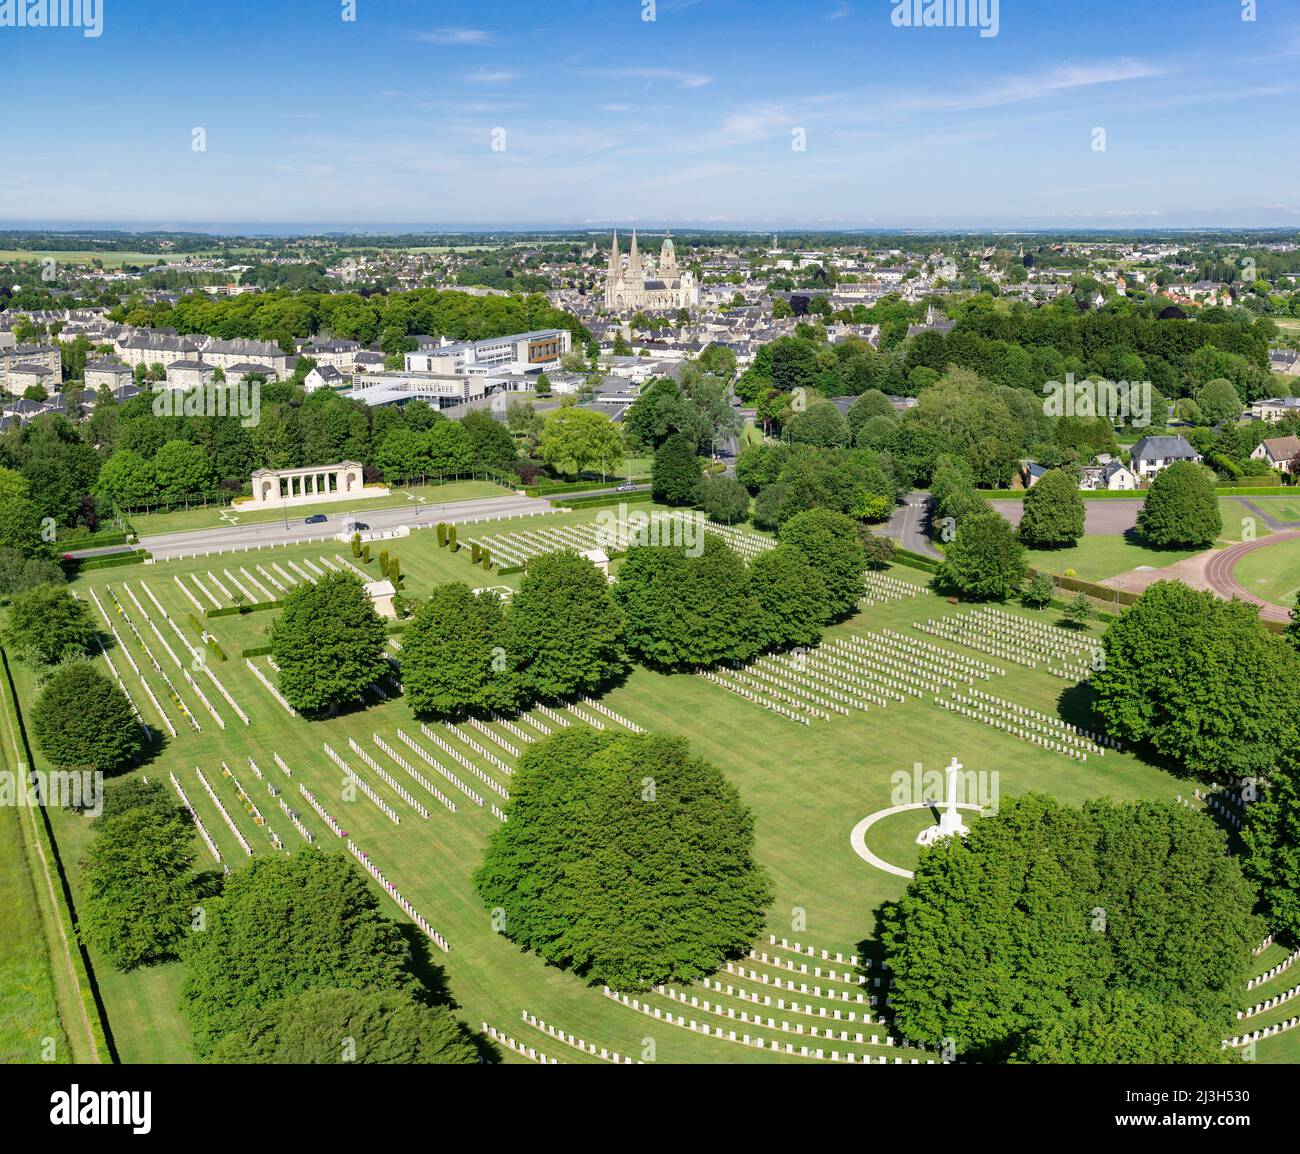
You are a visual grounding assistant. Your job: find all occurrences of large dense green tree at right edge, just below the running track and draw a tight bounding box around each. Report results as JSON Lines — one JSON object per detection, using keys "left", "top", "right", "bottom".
{"left": 1089, "top": 581, "right": 1300, "bottom": 780}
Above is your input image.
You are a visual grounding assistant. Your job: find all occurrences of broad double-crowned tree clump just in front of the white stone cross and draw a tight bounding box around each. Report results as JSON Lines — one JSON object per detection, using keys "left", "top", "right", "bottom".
{"left": 881, "top": 794, "right": 1264, "bottom": 1062}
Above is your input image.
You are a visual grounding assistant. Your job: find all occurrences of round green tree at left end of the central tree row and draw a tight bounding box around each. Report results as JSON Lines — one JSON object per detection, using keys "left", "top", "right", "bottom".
{"left": 270, "top": 573, "right": 389, "bottom": 715}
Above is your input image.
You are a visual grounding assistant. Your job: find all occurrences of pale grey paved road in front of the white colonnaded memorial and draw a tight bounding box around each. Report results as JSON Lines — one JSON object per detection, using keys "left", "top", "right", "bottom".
{"left": 140, "top": 495, "right": 551, "bottom": 558}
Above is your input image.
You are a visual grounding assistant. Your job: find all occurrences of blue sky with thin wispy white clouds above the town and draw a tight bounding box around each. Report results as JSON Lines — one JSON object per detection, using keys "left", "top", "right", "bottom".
{"left": 0, "top": 0, "right": 1300, "bottom": 227}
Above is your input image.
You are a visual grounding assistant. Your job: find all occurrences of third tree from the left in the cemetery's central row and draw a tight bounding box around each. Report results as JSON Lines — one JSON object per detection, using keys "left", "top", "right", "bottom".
{"left": 506, "top": 552, "right": 627, "bottom": 700}
